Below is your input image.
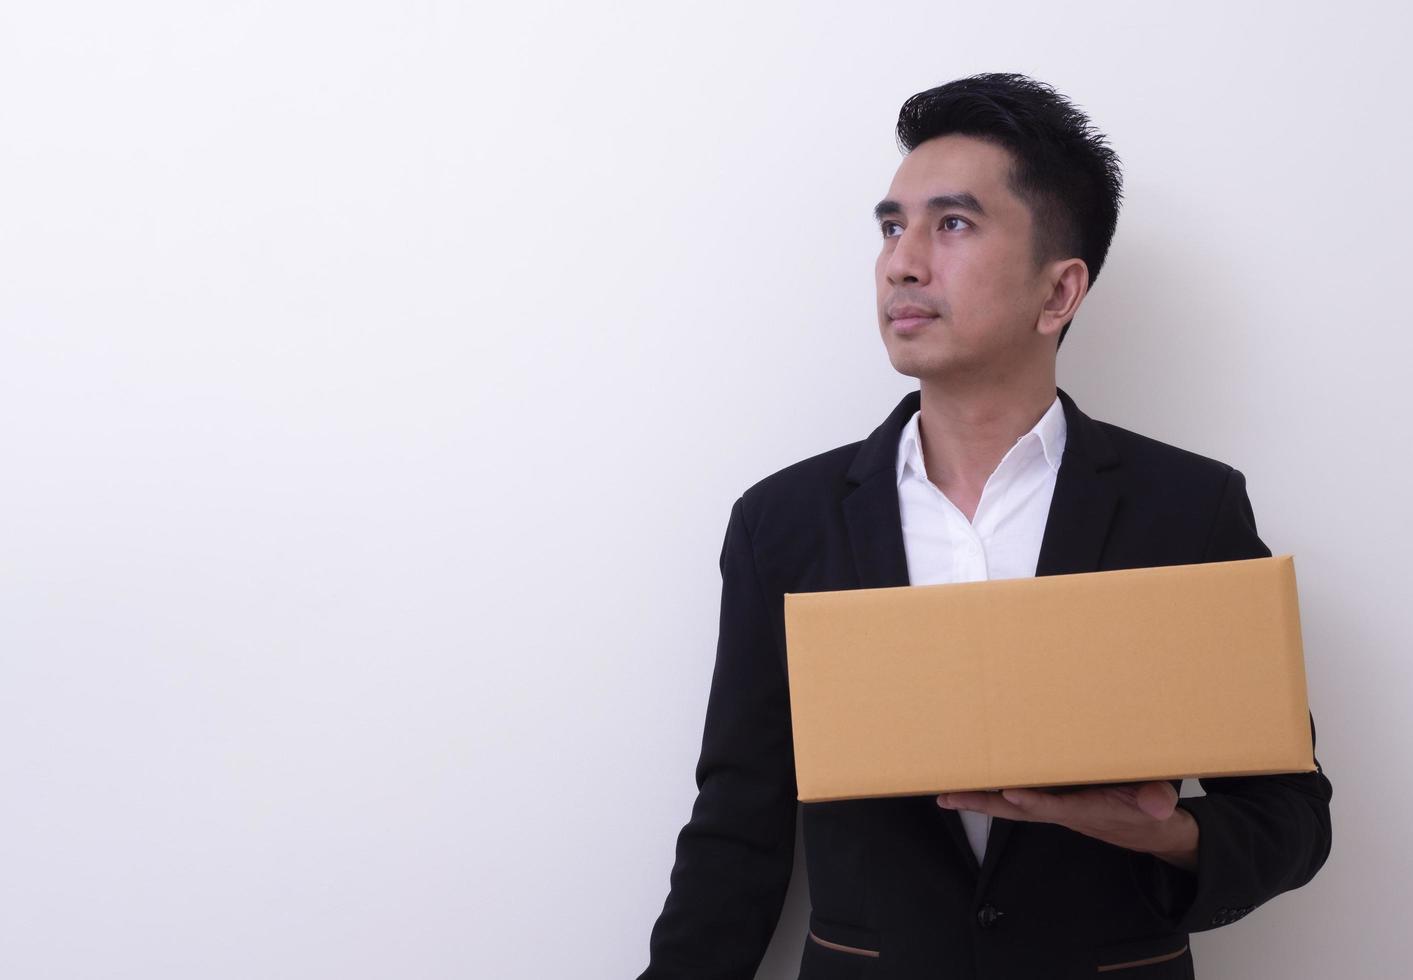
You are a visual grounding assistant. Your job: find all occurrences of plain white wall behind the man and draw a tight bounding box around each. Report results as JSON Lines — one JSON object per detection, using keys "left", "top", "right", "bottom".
{"left": 0, "top": 0, "right": 1413, "bottom": 980}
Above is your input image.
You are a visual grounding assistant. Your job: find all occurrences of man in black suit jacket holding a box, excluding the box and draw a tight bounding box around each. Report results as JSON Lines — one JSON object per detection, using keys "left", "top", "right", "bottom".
{"left": 640, "top": 75, "right": 1331, "bottom": 980}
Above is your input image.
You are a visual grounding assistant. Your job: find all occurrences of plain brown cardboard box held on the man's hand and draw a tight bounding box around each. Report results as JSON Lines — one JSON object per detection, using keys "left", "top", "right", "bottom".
{"left": 784, "top": 555, "right": 1316, "bottom": 802}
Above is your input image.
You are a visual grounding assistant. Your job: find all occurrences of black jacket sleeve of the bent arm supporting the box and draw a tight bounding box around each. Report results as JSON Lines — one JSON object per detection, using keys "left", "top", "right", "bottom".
{"left": 1129, "top": 469, "right": 1331, "bottom": 932}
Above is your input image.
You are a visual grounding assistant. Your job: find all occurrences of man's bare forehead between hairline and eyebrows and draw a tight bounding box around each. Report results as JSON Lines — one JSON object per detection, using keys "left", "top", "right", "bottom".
{"left": 887, "top": 133, "right": 1024, "bottom": 219}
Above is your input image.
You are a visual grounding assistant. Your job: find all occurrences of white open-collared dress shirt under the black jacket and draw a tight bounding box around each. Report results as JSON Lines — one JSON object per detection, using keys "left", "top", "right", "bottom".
{"left": 897, "top": 394, "right": 1065, "bottom": 861}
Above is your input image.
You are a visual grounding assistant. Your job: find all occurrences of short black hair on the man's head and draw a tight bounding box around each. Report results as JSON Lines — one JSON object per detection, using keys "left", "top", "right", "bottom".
{"left": 897, "top": 72, "right": 1123, "bottom": 349}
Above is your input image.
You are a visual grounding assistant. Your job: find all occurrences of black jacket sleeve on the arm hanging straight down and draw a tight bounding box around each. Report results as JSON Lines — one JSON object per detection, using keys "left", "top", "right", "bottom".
{"left": 639, "top": 497, "right": 798, "bottom": 980}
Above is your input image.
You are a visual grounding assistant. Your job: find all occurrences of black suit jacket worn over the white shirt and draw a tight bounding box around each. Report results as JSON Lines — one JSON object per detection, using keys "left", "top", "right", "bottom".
{"left": 640, "top": 390, "right": 1331, "bottom": 980}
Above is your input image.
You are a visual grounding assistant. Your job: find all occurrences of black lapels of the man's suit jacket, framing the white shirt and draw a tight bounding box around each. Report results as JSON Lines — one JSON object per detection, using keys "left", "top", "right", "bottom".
{"left": 842, "top": 388, "right": 1118, "bottom": 894}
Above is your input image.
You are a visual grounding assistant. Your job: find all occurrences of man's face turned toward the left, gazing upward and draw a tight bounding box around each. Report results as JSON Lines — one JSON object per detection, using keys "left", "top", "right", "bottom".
{"left": 875, "top": 134, "right": 1056, "bottom": 380}
